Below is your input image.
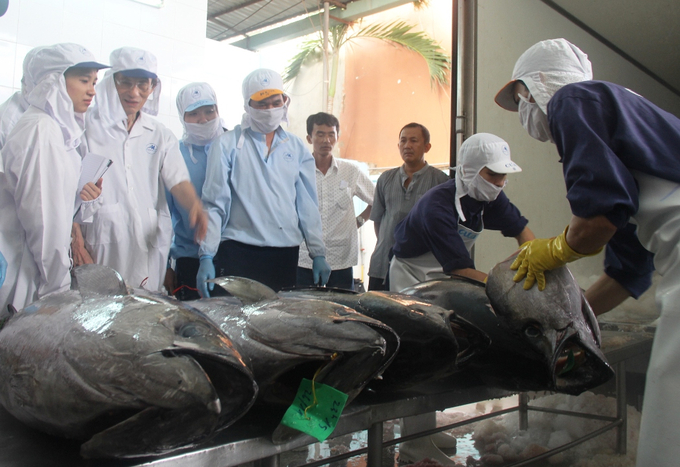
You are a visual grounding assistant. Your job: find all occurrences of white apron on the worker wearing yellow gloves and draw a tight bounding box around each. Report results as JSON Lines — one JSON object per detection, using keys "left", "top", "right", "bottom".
{"left": 632, "top": 171, "right": 680, "bottom": 467}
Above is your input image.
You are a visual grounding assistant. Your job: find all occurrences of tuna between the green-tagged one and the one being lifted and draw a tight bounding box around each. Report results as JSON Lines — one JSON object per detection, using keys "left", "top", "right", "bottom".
{"left": 279, "top": 287, "right": 489, "bottom": 391}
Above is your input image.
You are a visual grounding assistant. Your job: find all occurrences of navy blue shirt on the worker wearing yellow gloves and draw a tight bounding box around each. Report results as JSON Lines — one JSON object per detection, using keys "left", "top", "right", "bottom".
{"left": 548, "top": 81, "right": 668, "bottom": 296}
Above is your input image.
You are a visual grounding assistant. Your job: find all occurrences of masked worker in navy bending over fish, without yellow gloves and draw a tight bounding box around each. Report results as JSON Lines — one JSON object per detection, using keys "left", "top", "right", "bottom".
{"left": 390, "top": 133, "right": 534, "bottom": 292}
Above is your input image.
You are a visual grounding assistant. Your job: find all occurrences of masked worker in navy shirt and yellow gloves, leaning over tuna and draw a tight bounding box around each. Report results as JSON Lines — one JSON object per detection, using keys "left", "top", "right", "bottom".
{"left": 496, "top": 39, "right": 680, "bottom": 466}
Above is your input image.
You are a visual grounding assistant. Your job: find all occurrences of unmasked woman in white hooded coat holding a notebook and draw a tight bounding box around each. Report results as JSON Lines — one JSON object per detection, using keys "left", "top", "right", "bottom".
{"left": 0, "top": 43, "right": 107, "bottom": 311}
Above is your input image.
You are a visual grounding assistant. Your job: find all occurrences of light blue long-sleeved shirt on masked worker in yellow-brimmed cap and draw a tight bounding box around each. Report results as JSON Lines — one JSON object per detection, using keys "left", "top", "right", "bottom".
{"left": 199, "top": 125, "right": 325, "bottom": 258}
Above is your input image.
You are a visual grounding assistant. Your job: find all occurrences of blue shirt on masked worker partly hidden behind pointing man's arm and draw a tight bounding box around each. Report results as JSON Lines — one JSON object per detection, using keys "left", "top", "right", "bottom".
{"left": 165, "top": 141, "right": 210, "bottom": 259}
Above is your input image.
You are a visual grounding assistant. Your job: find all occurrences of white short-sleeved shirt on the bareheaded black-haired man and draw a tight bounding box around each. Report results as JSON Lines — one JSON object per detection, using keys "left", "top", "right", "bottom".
{"left": 298, "top": 157, "right": 375, "bottom": 270}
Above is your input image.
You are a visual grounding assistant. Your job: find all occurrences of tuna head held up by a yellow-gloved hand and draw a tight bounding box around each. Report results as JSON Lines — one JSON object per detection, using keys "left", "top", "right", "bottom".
{"left": 486, "top": 254, "right": 614, "bottom": 394}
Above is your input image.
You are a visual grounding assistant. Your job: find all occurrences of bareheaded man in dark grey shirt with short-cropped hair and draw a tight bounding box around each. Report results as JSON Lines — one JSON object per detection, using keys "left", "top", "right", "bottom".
{"left": 368, "top": 123, "right": 449, "bottom": 290}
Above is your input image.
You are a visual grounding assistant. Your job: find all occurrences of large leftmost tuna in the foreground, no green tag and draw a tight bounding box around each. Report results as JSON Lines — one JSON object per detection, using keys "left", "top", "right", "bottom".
{"left": 0, "top": 265, "right": 257, "bottom": 457}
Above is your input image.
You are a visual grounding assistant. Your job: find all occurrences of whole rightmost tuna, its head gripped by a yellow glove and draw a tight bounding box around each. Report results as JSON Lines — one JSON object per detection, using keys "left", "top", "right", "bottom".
{"left": 403, "top": 254, "right": 614, "bottom": 394}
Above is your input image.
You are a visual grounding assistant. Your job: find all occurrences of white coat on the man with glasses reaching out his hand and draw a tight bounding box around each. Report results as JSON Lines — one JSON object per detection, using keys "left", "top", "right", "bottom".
{"left": 85, "top": 111, "right": 189, "bottom": 291}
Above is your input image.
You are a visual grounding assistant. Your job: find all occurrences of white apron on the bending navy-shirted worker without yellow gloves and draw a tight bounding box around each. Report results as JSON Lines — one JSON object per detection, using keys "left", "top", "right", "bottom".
{"left": 390, "top": 223, "right": 484, "bottom": 292}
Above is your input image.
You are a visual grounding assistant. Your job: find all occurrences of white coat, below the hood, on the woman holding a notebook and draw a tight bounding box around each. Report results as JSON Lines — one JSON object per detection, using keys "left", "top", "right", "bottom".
{"left": 0, "top": 107, "right": 81, "bottom": 309}
